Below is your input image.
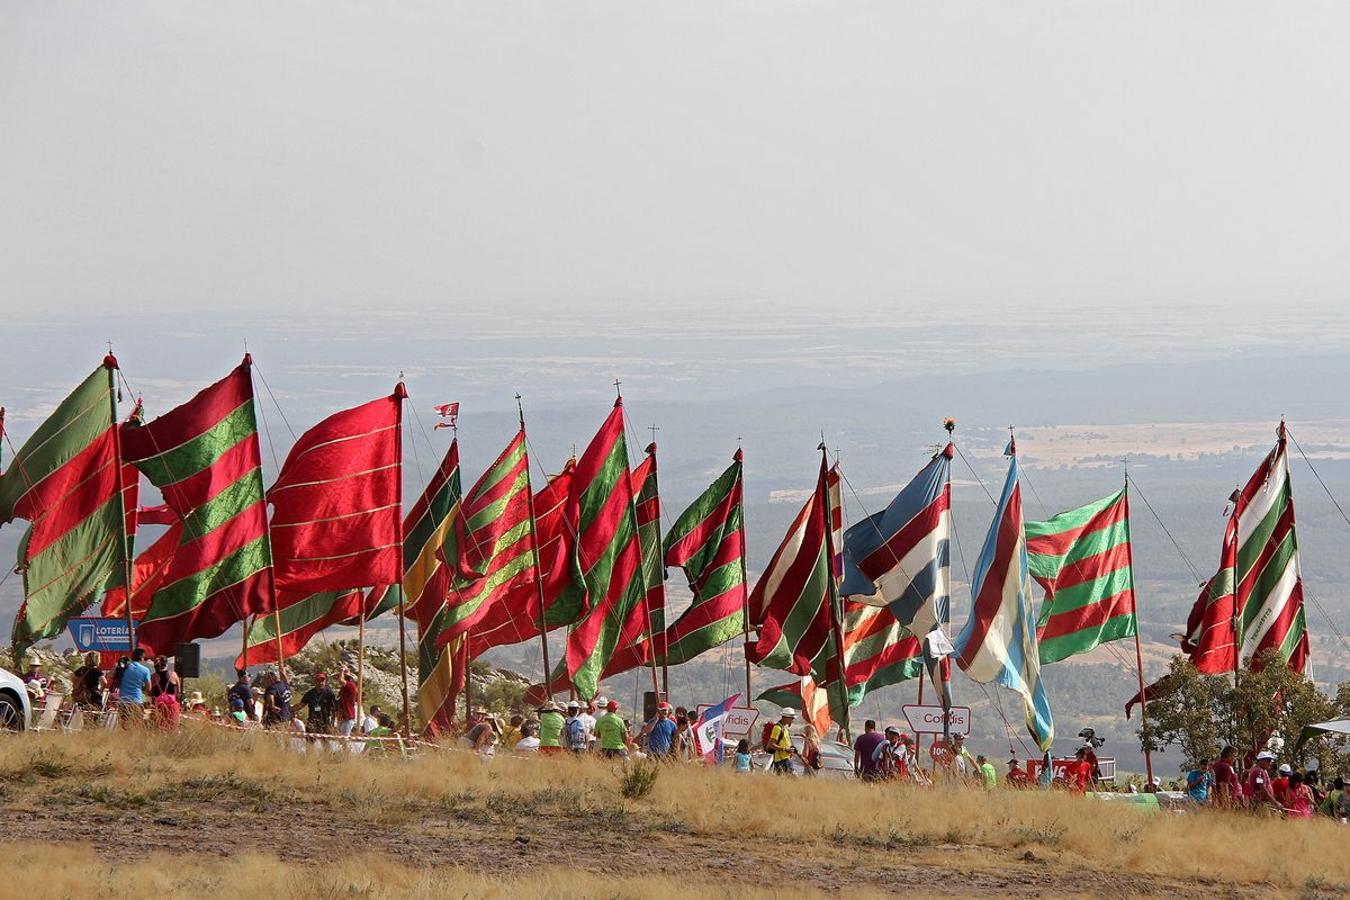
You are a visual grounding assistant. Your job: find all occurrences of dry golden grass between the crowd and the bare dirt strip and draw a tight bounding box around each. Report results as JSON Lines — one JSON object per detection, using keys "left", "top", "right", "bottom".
{"left": 0, "top": 725, "right": 1350, "bottom": 899}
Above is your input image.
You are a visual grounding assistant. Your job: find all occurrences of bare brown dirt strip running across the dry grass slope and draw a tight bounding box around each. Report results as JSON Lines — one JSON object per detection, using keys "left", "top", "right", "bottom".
{"left": 0, "top": 783, "right": 1268, "bottom": 897}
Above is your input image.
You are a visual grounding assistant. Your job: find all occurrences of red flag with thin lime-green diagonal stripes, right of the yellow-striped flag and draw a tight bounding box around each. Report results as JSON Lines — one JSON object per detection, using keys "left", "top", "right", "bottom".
{"left": 436, "top": 430, "right": 535, "bottom": 645}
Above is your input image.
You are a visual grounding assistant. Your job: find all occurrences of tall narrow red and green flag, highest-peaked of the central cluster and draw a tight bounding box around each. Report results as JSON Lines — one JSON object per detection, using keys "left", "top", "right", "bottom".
{"left": 567, "top": 398, "right": 647, "bottom": 699}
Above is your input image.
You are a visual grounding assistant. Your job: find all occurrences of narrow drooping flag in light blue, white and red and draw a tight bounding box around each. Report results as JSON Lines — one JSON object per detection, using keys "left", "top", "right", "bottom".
{"left": 954, "top": 441, "right": 1054, "bottom": 750}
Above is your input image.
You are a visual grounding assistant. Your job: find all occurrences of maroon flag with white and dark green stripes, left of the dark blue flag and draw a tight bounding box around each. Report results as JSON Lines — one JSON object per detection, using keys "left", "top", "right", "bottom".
{"left": 745, "top": 459, "right": 836, "bottom": 683}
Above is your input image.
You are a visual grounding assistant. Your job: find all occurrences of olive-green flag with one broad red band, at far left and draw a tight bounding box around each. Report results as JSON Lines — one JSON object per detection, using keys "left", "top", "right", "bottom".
{"left": 0, "top": 355, "right": 127, "bottom": 660}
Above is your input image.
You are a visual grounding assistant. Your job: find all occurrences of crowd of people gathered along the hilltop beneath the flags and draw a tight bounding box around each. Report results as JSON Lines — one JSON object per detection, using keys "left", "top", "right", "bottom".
{"left": 13, "top": 649, "right": 1350, "bottom": 819}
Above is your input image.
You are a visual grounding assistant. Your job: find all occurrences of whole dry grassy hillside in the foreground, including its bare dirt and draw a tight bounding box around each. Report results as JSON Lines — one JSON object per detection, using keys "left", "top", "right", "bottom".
{"left": 0, "top": 725, "right": 1350, "bottom": 899}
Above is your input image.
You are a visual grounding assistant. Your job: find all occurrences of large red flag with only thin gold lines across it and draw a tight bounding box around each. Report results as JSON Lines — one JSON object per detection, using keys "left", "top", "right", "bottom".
{"left": 267, "top": 382, "right": 408, "bottom": 598}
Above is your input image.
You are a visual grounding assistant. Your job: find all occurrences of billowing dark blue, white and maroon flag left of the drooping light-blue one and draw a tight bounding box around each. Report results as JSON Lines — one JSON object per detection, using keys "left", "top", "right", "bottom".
{"left": 841, "top": 444, "right": 953, "bottom": 634}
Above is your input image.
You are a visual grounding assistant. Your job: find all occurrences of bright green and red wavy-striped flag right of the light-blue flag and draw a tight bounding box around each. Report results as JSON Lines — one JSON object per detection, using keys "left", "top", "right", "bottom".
{"left": 1025, "top": 487, "right": 1137, "bottom": 664}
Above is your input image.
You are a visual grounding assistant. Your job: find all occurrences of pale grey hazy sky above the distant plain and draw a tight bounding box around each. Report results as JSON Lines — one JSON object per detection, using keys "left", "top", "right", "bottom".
{"left": 0, "top": 0, "right": 1350, "bottom": 319}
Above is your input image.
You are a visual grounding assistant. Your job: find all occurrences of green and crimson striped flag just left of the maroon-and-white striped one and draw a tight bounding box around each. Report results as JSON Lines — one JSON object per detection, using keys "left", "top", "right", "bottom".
{"left": 663, "top": 451, "right": 745, "bottom": 665}
